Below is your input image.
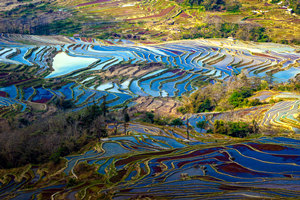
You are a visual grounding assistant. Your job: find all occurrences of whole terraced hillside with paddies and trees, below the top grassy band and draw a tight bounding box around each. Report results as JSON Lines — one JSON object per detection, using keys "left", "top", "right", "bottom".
{"left": 0, "top": 34, "right": 300, "bottom": 199}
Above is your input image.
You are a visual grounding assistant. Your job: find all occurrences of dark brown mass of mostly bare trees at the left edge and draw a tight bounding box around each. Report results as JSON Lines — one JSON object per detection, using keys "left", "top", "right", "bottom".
{"left": 0, "top": 101, "right": 108, "bottom": 168}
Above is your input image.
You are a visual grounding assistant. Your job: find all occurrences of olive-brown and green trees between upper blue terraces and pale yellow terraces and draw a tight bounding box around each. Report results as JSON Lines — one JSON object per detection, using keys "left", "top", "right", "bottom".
{"left": 178, "top": 72, "right": 269, "bottom": 114}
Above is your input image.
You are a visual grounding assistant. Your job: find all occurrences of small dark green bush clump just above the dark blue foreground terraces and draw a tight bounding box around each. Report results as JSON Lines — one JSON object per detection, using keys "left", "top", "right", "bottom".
{"left": 211, "top": 120, "right": 259, "bottom": 138}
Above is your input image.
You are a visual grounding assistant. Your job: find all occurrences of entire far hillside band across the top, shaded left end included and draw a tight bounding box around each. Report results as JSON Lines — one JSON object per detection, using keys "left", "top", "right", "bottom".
{"left": 0, "top": 0, "right": 300, "bottom": 44}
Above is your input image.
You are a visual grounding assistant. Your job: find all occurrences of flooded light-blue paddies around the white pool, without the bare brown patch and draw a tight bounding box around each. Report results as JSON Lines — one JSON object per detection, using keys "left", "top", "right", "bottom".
{"left": 0, "top": 35, "right": 300, "bottom": 112}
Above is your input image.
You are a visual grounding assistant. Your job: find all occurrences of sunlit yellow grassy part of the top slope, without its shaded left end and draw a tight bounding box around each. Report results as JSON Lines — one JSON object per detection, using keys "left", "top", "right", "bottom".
{"left": 51, "top": 0, "right": 300, "bottom": 42}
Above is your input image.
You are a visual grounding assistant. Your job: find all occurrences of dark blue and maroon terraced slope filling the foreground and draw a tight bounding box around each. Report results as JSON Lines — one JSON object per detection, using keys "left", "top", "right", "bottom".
{"left": 0, "top": 128, "right": 300, "bottom": 199}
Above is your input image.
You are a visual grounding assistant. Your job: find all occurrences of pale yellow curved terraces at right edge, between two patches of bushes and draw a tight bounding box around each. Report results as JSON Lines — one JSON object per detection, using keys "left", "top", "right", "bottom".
{"left": 183, "top": 91, "right": 300, "bottom": 133}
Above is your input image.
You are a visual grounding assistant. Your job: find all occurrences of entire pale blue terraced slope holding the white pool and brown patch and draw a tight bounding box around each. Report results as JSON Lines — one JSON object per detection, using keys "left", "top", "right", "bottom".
{"left": 0, "top": 34, "right": 300, "bottom": 124}
